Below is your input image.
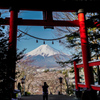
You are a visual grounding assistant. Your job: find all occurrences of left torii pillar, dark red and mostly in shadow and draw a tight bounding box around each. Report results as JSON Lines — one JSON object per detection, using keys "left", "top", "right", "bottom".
{"left": 9, "top": 7, "right": 18, "bottom": 89}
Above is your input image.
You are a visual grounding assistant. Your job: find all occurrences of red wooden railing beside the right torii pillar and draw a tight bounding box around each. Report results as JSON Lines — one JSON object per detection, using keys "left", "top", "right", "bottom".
{"left": 74, "top": 60, "right": 100, "bottom": 91}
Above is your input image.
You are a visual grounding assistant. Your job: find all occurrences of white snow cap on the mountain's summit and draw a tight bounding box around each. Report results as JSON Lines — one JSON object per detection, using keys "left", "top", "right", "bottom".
{"left": 27, "top": 44, "right": 60, "bottom": 57}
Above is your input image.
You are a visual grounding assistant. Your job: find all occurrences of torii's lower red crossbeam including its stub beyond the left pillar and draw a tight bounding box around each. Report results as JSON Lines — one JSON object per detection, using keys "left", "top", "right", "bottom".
{"left": 2, "top": 18, "right": 79, "bottom": 27}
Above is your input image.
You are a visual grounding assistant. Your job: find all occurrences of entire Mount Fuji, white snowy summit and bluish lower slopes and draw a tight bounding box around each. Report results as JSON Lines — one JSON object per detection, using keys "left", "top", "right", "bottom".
{"left": 24, "top": 44, "right": 70, "bottom": 68}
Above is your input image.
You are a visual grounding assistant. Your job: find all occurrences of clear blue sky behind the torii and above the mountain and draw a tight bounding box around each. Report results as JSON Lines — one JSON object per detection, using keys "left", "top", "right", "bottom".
{"left": 1, "top": 10, "right": 75, "bottom": 54}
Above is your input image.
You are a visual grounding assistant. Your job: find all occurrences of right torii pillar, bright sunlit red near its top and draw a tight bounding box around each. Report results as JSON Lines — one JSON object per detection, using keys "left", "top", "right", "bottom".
{"left": 78, "top": 9, "right": 93, "bottom": 89}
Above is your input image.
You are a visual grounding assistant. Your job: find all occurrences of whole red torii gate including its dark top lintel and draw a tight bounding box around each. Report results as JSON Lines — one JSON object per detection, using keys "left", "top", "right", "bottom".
{"left": 0, "top": 0, "right": 99, "bottom": 99}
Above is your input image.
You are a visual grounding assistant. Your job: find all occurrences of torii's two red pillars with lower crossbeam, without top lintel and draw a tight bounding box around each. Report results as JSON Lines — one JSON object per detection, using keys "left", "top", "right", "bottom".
{"left": 5, "top": 9, "right": 92, "bottom": 95}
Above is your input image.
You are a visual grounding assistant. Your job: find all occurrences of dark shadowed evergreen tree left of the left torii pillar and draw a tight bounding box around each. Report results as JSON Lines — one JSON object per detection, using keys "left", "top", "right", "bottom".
{"left": 0, "top": 28, "right": 24, "bottom": 100}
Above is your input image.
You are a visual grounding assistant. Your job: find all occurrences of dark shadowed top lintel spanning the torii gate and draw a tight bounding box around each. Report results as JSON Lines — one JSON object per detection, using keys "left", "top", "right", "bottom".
{"left": 0, "top": 0, "right": 100, "bottom": 12}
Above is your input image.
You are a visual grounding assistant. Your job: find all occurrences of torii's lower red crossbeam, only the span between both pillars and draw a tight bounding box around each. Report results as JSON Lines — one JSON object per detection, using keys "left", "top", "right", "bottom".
{"left": 18, "top": 20, "right": 79, "bottom": 27}
